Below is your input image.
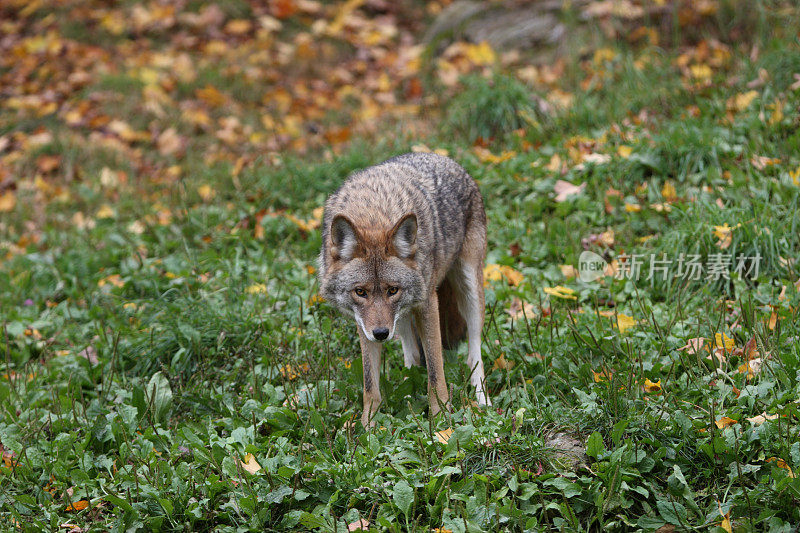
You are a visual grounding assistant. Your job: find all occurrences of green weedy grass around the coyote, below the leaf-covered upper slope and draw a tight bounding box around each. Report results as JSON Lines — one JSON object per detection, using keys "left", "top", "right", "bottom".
{"left": 0, "top": 1, "right": 800, "bottom": 532}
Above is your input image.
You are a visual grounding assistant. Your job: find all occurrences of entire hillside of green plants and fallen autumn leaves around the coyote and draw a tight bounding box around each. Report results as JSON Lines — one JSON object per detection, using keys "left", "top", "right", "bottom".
{"left": 0, "top": 0, "right": 800, "bottom": 532}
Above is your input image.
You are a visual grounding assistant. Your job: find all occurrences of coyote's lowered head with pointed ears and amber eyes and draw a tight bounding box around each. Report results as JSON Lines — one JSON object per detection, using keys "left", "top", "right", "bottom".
{"left": 320, "top": 213, "right": 425, "bottom": 341}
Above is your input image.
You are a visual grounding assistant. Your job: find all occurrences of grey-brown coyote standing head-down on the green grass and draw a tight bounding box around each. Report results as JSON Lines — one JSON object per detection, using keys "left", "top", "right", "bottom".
{"left": 318, "top": 153, "right": 491, "bottom": 427}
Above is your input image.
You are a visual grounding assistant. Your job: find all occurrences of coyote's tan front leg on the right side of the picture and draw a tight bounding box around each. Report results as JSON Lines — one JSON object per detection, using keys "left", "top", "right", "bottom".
{"left": 415, "top": 291, "right": 450, "bottom": 416}
